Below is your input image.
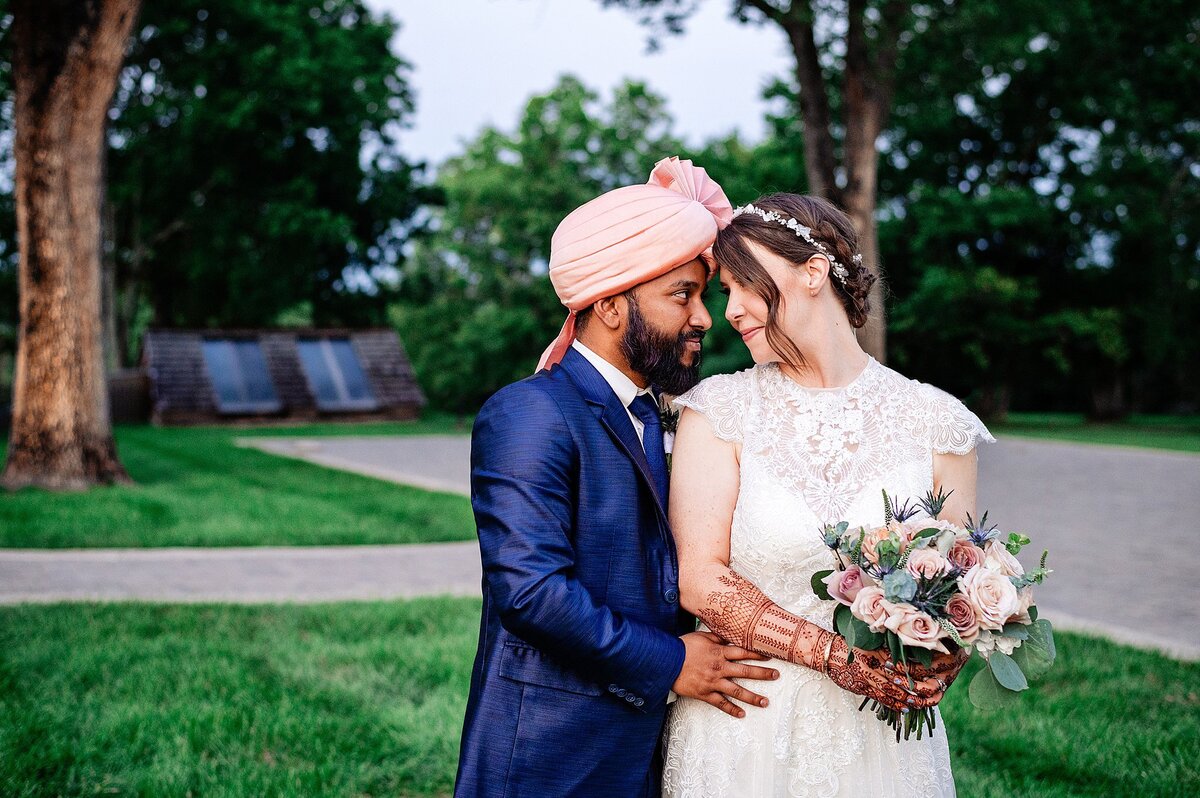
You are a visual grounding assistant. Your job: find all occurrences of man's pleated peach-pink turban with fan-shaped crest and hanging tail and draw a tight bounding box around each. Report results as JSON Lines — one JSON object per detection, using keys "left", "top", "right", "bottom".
{"left": 538, "top": 157, "right": 733, "bottom": 371}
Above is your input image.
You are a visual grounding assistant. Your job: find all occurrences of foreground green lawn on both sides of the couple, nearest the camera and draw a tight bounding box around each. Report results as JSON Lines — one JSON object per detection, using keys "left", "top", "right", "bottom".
{"left": 0, "top": 599, "right": 1200, "bottom": 798}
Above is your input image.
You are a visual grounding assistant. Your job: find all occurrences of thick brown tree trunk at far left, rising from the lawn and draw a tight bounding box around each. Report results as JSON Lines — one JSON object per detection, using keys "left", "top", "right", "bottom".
{"left": 0, "top": 0, "right": 139, "bottom": 490}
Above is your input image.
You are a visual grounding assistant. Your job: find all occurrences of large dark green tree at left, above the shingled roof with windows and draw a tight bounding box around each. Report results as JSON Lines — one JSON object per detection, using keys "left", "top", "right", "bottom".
{"left": 99, "top": 0, "right": 430, "bottom": 360}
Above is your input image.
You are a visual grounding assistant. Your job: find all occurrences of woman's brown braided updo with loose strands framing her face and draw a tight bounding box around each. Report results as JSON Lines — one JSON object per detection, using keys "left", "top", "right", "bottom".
{"left": 713, "top": 193, "right": 875, "bottom": 366}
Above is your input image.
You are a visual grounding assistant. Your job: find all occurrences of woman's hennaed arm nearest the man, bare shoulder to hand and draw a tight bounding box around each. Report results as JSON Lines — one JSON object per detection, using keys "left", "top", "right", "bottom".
{"left": 671, "top": 409, "right": 942, "bottom": 708}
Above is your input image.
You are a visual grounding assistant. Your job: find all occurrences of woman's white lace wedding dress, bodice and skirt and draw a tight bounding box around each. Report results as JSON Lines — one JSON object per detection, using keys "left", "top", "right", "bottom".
{"left": 662, "top": 359, "right": 994, "bottom": 798}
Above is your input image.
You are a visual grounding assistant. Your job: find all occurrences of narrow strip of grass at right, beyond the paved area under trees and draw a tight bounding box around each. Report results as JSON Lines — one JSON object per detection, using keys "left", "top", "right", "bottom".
{"left": 991, "top": 413, "right": 1200, "bottom": 452}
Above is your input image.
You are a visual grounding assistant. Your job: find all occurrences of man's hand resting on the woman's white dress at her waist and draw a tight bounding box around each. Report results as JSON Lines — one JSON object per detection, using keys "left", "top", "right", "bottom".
{"left": 671, "top": 631, "right": 779, "bottom": 718}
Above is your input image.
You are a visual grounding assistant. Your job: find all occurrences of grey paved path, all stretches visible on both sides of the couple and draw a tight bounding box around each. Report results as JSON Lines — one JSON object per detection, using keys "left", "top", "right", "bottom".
{"left": 0, "top": 436, "right": 1200, "bottom": 659}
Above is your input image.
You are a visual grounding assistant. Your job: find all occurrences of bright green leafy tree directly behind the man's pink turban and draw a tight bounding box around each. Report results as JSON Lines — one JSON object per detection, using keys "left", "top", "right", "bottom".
{"left": 392, "top": 77, "right": 680, "bottom": 412}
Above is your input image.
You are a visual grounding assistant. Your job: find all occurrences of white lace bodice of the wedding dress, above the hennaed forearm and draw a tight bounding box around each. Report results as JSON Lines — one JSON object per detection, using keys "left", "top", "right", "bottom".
{"left": 676, "top": 359, "right": 994, "bottom": 628}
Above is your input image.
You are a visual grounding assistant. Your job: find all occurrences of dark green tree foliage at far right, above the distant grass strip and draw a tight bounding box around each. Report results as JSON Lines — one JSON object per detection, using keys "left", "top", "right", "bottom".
{"left": 881, "top": 0, "right": 1200, "bottom": 418}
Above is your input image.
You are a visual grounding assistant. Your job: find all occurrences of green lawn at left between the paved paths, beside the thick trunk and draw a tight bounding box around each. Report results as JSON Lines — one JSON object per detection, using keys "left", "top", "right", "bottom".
{"left": 0, "top": 418, "right": 475, "bottom": 548}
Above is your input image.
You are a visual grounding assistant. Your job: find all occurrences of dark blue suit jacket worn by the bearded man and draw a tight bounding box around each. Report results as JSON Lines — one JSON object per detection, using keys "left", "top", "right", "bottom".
{"left": 455, "top": 349, "right": 694, "bottom": 798}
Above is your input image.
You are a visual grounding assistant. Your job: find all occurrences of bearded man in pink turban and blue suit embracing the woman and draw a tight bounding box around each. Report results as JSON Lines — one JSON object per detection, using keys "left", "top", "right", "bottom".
{"left": 455, "top": 158, "right": 778, "bottom": 798}
